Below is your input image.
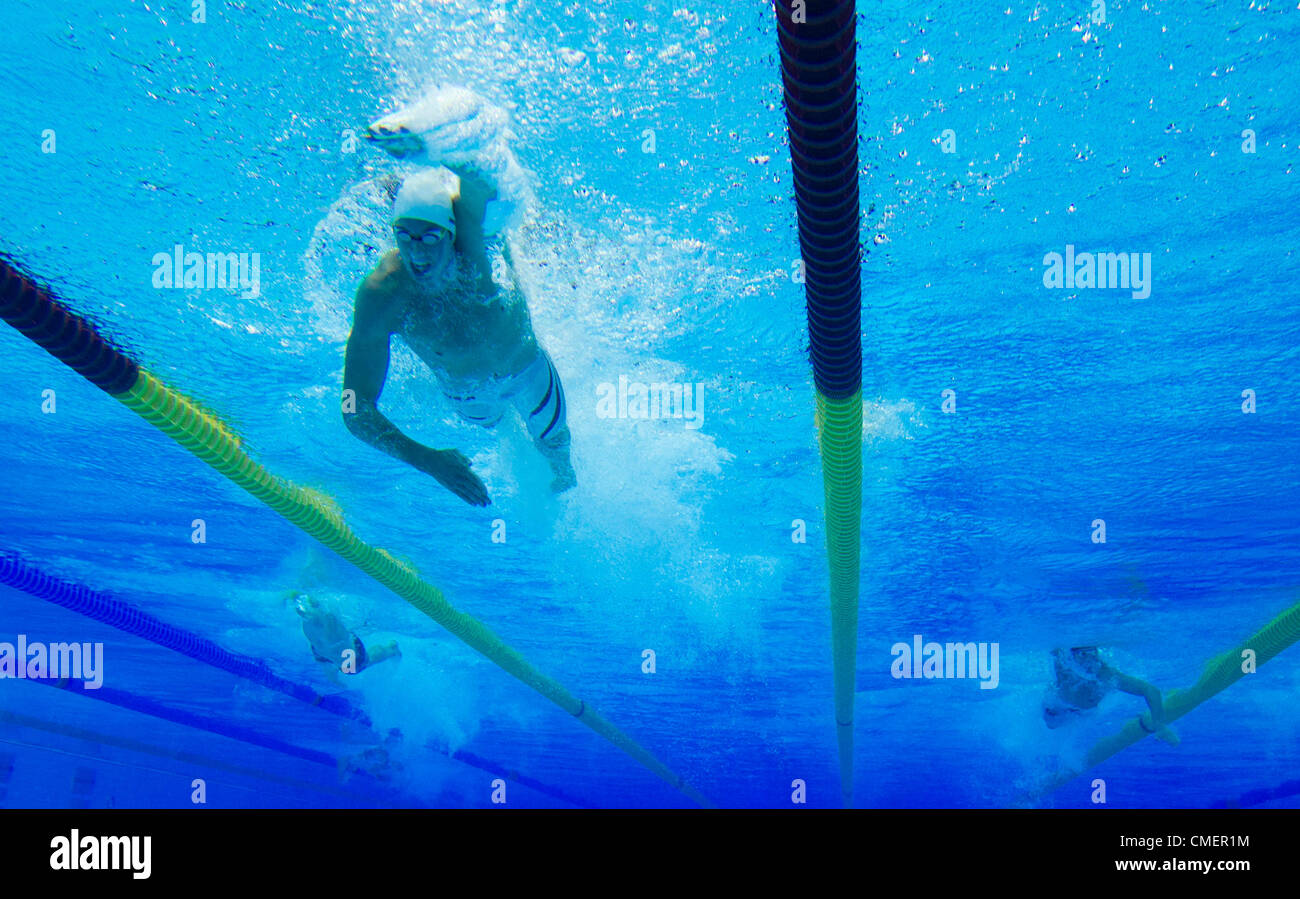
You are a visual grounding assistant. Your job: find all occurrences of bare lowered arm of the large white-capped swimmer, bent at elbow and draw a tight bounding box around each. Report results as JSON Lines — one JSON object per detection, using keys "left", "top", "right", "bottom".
{"left": 343, "top": 285, "right": 489, "bottom": 505}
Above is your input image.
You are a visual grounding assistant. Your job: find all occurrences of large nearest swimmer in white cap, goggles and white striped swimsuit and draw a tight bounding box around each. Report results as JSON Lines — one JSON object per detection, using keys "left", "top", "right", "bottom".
{"left": 343, "top": 166, "right": 577, "bottom": 505}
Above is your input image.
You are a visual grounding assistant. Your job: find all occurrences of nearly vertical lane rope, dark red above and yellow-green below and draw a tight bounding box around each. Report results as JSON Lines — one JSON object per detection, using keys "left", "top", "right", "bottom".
{"left": 775, "top": 0, "right": 862, "bottom": 808}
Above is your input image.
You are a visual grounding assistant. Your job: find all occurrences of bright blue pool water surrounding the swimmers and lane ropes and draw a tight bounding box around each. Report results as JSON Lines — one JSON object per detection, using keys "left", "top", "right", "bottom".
{"left": 0, "top": 0, "right": 1300, "bottom": 808}
